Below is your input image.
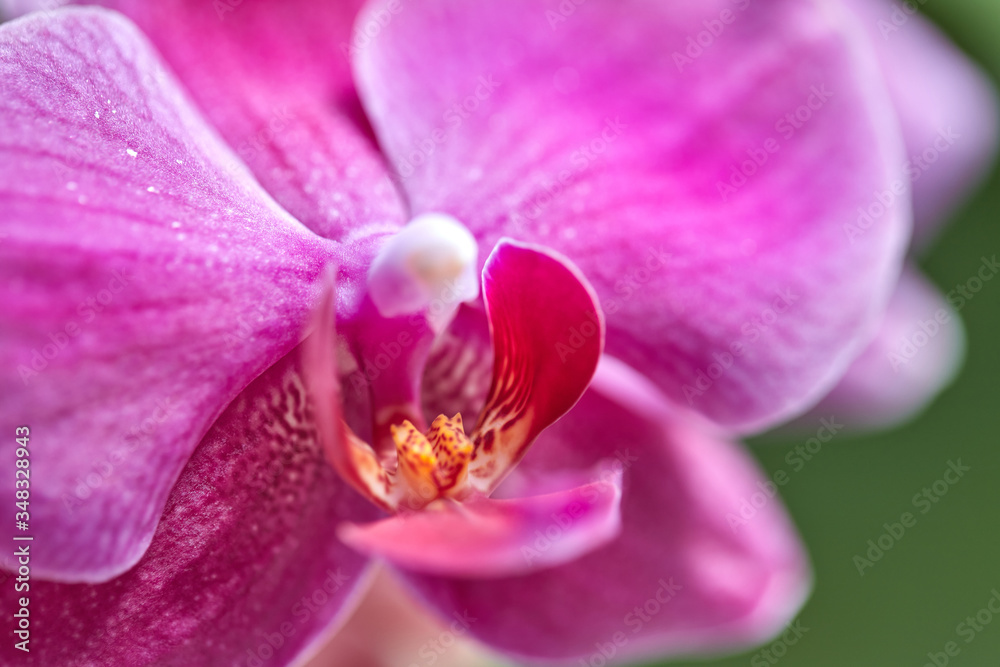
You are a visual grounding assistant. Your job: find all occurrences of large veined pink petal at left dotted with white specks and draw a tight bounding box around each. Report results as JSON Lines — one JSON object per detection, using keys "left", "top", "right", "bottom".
{"left": 0, "top": 9, "right": 332, "bottom": 582}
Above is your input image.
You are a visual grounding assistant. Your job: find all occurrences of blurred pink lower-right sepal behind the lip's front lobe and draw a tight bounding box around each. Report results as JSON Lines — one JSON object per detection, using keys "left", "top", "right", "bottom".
{"left": 398, "top": 364, "right": 810, "bottom": 664}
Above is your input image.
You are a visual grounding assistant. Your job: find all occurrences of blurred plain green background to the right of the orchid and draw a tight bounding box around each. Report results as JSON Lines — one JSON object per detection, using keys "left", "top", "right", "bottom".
{"left": 665, "top": 0, "right": 1000, "bottom": 667}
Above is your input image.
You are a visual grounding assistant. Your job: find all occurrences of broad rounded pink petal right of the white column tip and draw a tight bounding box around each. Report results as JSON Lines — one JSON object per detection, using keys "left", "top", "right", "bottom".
{"left": 355, "top": 0, "right": 909, "bottom": 428}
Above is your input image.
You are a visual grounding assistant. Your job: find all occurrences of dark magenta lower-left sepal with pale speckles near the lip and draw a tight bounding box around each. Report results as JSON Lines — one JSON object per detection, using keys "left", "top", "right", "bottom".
{"left": 0, "top": 353, "right": 375, "bottom": 667}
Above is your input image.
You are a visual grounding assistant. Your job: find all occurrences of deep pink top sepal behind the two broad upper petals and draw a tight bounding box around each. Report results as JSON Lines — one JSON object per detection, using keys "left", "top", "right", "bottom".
{"left": 18, "top": 0, "right": 406, "bottom": 250}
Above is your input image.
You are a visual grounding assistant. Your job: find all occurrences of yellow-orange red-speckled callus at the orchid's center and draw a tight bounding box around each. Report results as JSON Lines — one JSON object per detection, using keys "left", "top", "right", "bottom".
{"left": 392, "top": 414, "right": 473, "bottom": 507}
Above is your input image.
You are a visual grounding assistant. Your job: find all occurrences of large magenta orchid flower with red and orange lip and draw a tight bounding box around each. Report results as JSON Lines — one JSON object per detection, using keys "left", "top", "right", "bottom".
{"left": 0, "top": 0, "right": 992, "bottom": 667}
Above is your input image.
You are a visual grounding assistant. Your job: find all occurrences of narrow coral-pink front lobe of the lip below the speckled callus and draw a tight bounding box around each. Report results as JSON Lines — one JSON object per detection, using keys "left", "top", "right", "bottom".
{"left": 339, "top": 471, "right": 621, "bottom": 578}
